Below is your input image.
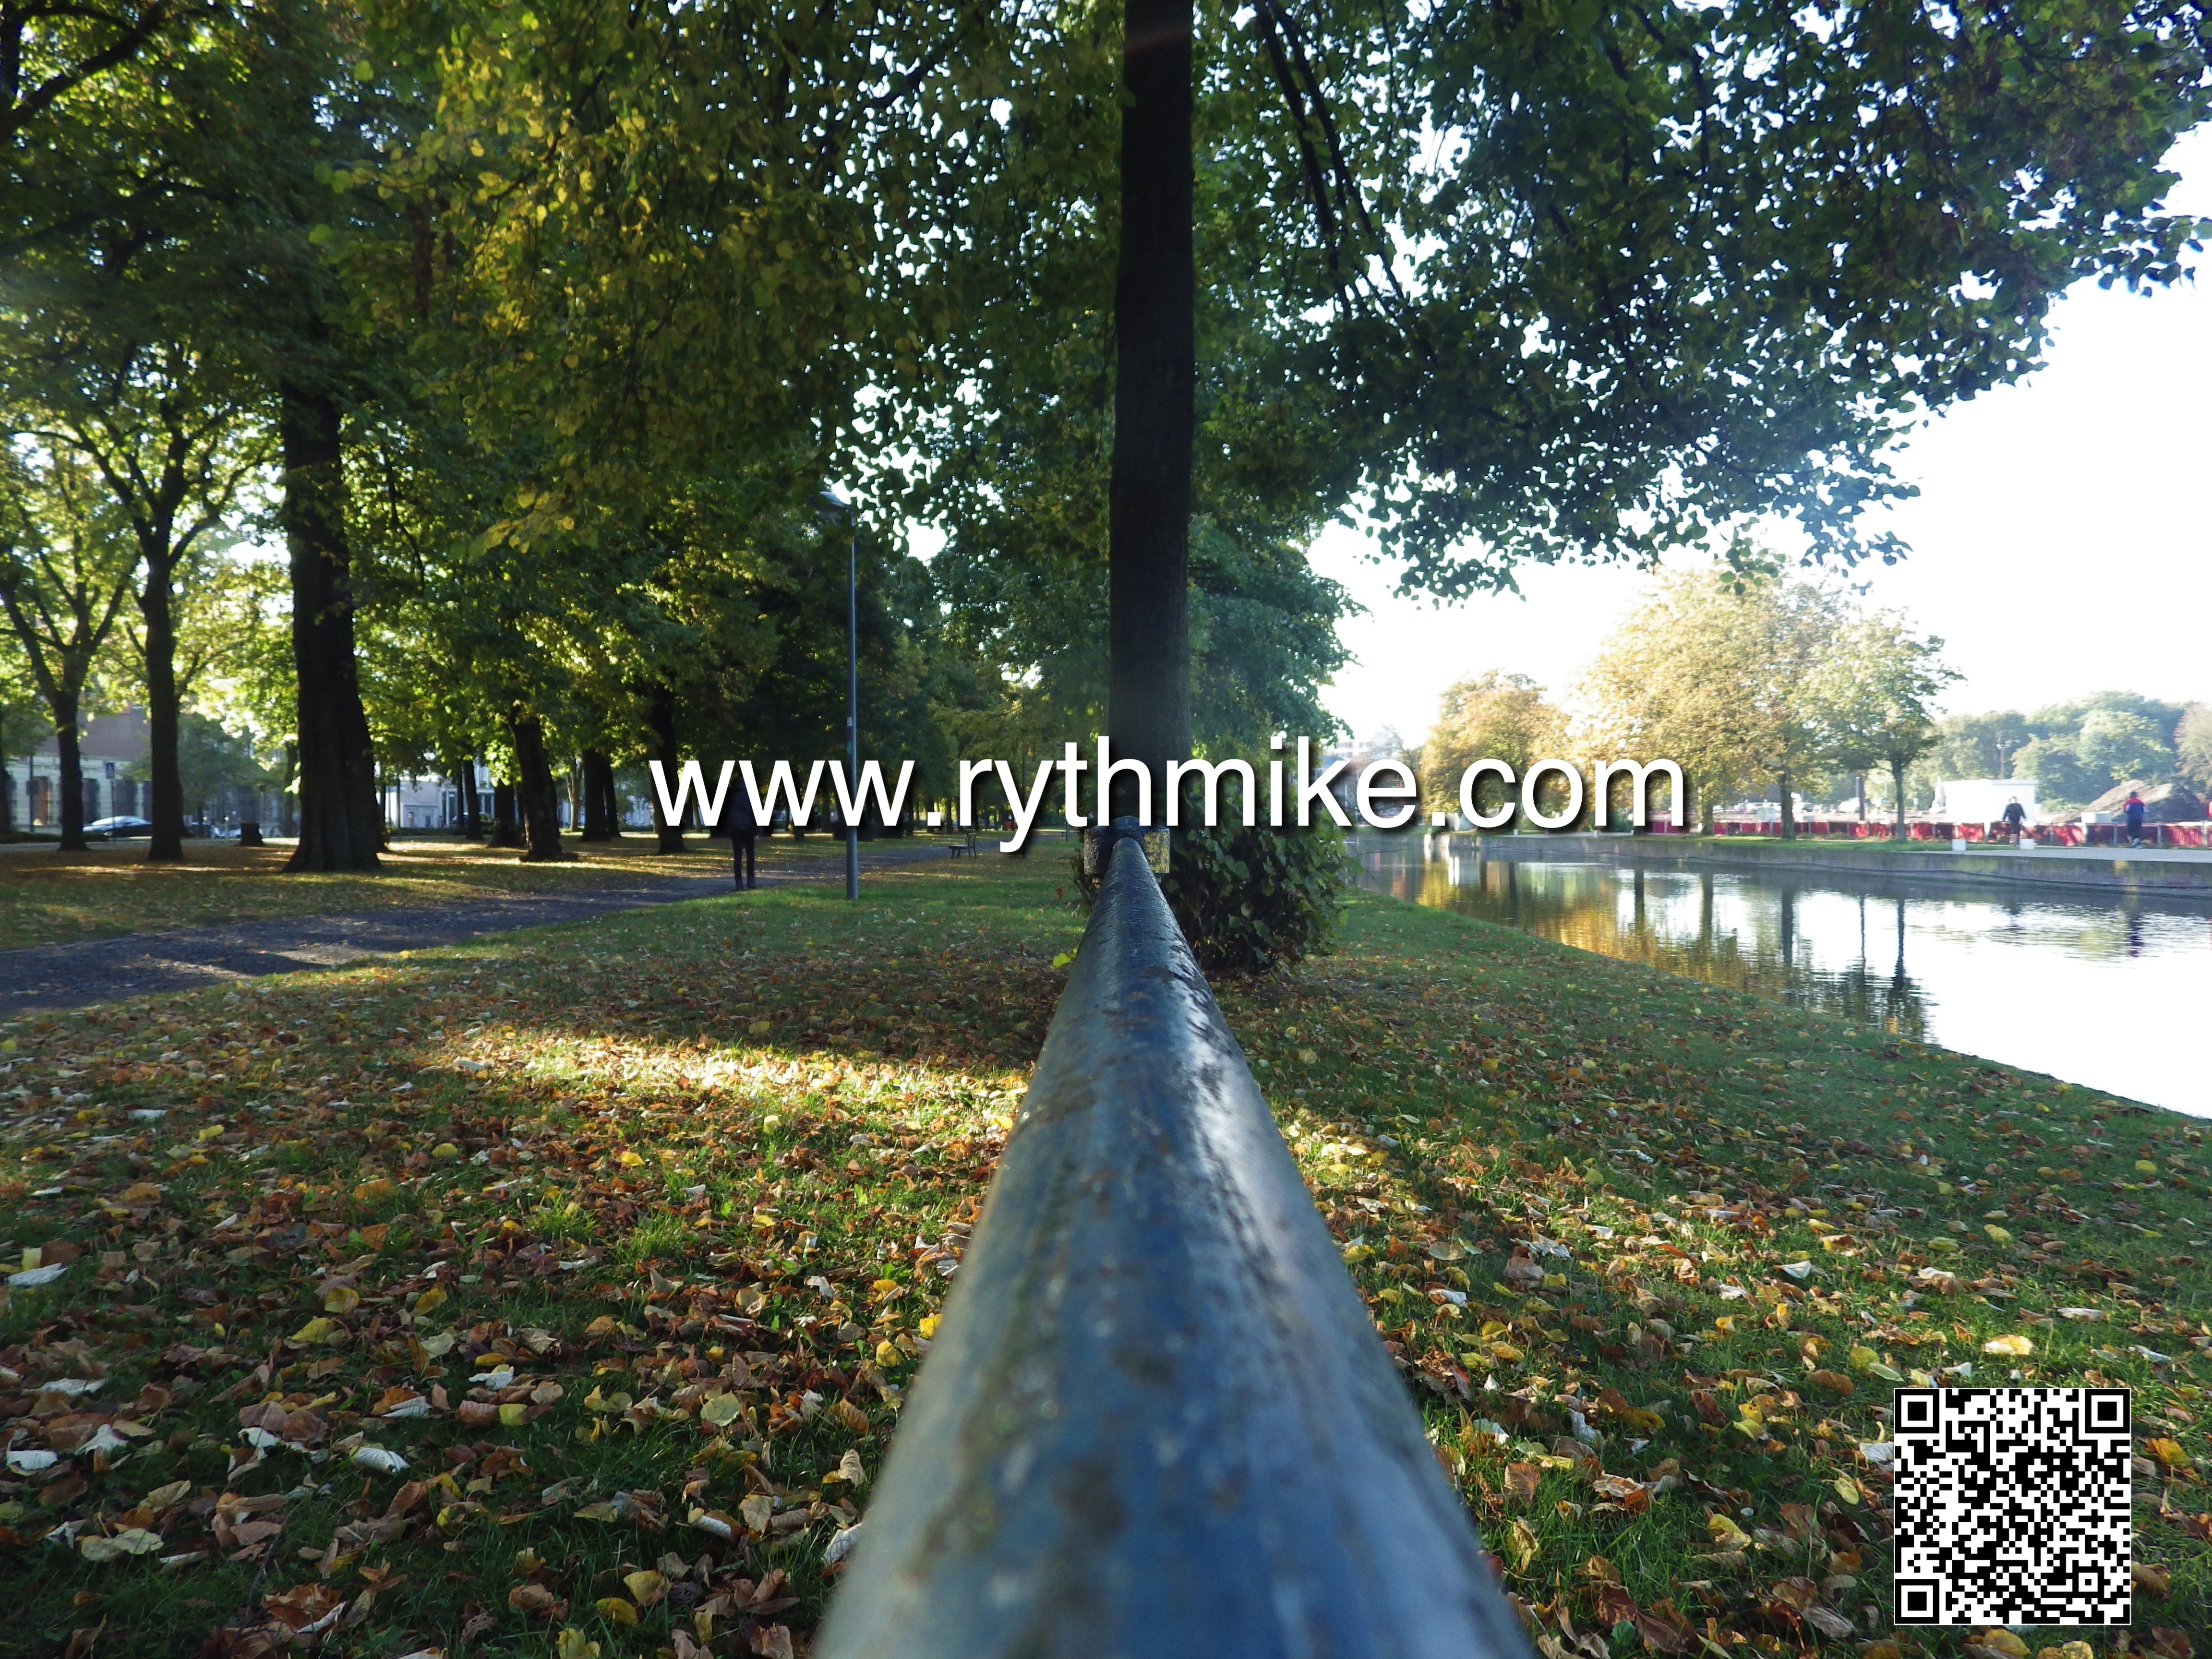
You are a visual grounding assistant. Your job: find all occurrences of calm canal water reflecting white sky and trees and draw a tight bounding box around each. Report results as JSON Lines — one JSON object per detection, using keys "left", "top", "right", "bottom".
{"left": 1356, "top": 834, "right": 2212, "bottom": 1117}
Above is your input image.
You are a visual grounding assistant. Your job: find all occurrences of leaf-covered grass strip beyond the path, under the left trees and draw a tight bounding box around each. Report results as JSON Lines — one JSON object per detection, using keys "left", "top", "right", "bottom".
{"left": 0, "top": 832, "right": 880, "bottom": 951}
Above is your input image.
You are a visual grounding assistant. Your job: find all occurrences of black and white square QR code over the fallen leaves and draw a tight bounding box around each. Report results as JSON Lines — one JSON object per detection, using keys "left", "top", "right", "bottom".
{"left": 1896, "top": 1389, "right": 2130, "bottom": 1623}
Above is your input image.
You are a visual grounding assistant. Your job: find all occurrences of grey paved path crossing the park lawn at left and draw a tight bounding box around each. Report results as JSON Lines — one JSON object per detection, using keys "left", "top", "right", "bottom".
{"left": 0, "top": 845, "right": 945, "bottom": 1015}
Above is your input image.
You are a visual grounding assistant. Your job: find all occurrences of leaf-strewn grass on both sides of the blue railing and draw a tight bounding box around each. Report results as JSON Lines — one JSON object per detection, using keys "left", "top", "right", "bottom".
{"left": 0, "top": 856, "right": 2212, "bottom": 1659}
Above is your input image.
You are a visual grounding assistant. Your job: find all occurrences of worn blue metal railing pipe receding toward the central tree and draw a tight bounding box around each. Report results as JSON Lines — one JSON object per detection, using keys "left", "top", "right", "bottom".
{"left": 816, "top": 841, "right": 1528, "bottom": 1659}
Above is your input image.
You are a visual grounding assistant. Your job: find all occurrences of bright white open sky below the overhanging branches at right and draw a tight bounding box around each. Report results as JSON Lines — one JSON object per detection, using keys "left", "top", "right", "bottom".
{"left": 1314, "top": 128, "right": 2212, "bottom": 743}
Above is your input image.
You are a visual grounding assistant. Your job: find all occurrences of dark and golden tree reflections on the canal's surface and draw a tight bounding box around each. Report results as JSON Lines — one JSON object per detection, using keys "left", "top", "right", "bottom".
{"left": 1367, "top": 856, "right": 1929, "bottom": 1040}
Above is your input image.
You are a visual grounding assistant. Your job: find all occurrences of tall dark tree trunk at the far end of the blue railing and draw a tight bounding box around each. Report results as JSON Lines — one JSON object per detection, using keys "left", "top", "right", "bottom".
{"left": 1106, "top": 0, "right": 1197, "bottom": 818}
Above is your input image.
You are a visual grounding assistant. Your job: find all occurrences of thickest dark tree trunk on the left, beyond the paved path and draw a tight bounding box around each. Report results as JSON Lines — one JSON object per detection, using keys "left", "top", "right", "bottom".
{"left": 279, "top": 383, "right": 383, "bottom": 869}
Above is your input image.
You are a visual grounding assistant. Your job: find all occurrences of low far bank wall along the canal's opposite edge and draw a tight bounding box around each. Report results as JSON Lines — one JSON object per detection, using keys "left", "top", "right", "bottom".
{"left": 1429, "top": 832, "right": 2212, "bottom": 898}
